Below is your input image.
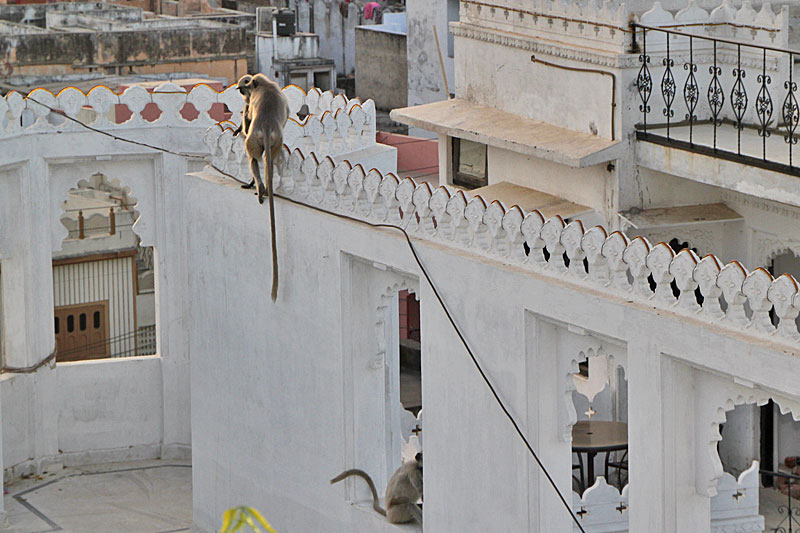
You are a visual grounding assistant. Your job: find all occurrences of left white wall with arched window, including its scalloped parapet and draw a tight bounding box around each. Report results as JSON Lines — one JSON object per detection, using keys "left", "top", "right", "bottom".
{"left": 0, "top": 80, "right": 396, "bottom": 490}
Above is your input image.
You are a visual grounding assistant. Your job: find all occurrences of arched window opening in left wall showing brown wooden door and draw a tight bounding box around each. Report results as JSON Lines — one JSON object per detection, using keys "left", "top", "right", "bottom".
{"left": 53, "top": 173, "right": 156, "bottom": 362}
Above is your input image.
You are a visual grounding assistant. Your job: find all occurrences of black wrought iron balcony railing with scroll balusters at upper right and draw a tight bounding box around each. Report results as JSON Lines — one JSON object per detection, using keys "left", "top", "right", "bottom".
{"left": 631, "top": 24, "right": 800, "bottom": 175}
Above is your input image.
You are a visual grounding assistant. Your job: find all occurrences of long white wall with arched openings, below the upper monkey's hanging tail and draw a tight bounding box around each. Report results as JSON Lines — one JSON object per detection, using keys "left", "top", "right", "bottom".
{"left": 187, "top": 155, "right": 800, "bottom": 533}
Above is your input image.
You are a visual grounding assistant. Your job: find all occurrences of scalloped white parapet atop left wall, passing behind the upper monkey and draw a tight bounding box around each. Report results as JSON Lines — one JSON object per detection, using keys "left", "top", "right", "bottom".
{"left": 0, "top": 83, "right": 376, "bottom": 156}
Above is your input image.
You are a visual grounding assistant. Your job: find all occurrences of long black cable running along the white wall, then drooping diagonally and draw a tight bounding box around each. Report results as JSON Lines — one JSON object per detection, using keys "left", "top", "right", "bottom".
{"left": 21, "top": 96, "right": 586, "bottom": 533}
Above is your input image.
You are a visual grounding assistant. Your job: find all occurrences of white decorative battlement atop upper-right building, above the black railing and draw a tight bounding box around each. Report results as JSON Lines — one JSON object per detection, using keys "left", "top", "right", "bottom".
{"left": 451, "top": 0, "right": 790, "bottom": 66}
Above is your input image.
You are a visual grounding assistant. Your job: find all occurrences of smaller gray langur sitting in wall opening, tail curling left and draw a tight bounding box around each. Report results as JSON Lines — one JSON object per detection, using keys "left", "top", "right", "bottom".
{"left": 331, "top": 453, "right": 422, "bottom": 524}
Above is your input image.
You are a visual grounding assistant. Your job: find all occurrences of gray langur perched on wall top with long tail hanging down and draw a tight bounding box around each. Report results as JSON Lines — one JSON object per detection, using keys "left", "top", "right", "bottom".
{"left": 238, "top": 74, "right": 289, "bottom": 302}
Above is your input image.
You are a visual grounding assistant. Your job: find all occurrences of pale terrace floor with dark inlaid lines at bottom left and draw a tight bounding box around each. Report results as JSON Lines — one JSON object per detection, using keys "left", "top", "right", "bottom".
{"left": 4, "top": 460, "right": 192, "bottom": 533}
